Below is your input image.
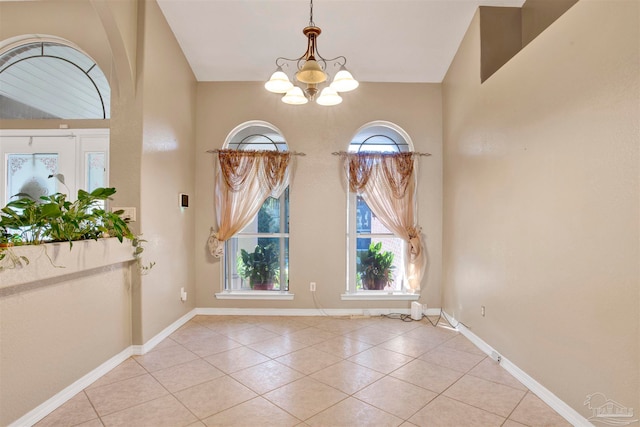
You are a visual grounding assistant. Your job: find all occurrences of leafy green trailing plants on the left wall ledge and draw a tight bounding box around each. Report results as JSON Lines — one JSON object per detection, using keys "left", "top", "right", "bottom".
{"left": 0, "top": 187, "right": 155, "bottom": 273}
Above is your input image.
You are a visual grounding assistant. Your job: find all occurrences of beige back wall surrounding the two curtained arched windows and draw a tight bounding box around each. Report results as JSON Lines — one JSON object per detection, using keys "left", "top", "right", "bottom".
{"left": 195, "top": 83, "right": 442, "bottom": 309}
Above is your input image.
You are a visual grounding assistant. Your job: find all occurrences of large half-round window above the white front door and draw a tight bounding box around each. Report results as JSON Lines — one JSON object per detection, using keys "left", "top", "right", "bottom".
{"left": 0, "top": 37, "right": 111, "bottom": 119}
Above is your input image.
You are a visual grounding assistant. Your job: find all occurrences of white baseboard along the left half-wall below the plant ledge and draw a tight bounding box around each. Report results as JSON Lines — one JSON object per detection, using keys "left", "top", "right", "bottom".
{"left": 9, "top": 346, "right": 133, "bottom": 427}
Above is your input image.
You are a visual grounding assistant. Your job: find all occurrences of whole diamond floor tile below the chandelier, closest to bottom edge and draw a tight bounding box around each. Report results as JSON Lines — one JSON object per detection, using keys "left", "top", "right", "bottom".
{"left": 264, "top": 377, "right": 347, "bottom": 420}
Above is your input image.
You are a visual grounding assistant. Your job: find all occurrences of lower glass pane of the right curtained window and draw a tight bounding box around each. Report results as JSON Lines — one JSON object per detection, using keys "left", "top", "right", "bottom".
{"left": 356, "top": 237, "right": 404, "bottom": 291}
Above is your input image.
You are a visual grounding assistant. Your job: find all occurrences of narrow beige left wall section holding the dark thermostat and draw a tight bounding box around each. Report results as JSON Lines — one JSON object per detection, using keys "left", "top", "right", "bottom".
{"left": 139, "top": 1, "right": 198, "bottom": 344}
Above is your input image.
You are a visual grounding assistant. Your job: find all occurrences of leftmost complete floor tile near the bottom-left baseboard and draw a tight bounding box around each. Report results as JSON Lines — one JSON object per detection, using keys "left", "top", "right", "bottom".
{"left": 85, "top": 374, "right": 169, "bottom": 416}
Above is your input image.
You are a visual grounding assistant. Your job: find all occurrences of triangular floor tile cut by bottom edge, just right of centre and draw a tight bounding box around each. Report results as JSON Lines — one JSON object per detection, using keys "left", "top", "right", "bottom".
{"left": 306, "top": 397, "right": 402, "bottom": 427}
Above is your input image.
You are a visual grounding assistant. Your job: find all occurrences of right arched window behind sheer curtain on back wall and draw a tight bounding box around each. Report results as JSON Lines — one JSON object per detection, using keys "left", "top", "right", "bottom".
{"left": 347, "top": 121, "right": 413, "bottom": 295}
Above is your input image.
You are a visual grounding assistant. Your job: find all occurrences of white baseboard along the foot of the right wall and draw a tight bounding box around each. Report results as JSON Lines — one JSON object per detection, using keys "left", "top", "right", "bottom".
{"left": 444, "top": 313, "right": 593, "bottom": 427}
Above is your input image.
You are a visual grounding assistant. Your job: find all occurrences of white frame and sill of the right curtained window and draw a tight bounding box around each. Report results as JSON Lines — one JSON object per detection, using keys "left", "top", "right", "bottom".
{"left": 341, "top": 121, "right": 420, "bottom": 301}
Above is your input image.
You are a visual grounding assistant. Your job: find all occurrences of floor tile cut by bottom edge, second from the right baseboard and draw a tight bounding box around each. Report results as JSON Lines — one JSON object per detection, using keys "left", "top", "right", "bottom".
{"left": 409, "top": 395, "right": 504, "bottom": 427}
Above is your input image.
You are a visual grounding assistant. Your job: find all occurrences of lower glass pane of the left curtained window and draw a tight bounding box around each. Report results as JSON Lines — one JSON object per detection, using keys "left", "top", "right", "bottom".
{"left": 225, "top": 236, "right": 289, "bottom": 291}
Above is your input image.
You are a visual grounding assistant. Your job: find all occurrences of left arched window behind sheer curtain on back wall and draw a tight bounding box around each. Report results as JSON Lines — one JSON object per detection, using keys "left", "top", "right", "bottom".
{"left": 224, "top": 121, "right": 289, "bottom": 293}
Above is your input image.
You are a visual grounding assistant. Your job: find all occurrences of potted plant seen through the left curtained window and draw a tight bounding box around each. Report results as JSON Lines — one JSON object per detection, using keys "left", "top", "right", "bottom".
{"left": 237, "top": 244, "right": 280, "bottom": 290}
